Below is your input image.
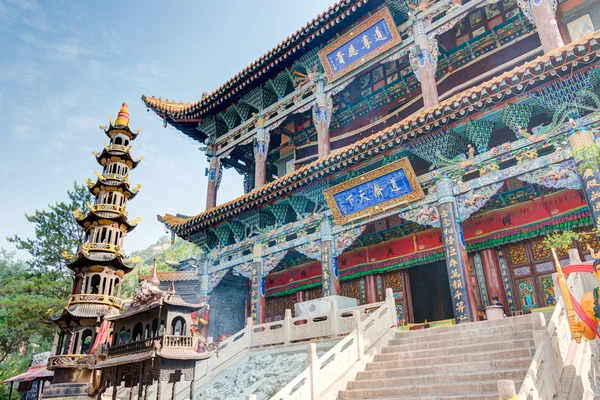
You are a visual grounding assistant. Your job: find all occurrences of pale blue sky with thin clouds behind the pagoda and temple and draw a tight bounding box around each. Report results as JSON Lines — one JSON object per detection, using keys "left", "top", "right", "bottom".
{"left": 0, "top": 0, "right": 333, "bottom": 256}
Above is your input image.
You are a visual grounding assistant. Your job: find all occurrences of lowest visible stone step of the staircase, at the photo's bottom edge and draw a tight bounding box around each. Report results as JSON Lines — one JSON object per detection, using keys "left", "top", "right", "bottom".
{"left": 339, "top": 380, "right": 521, "bottom": 400}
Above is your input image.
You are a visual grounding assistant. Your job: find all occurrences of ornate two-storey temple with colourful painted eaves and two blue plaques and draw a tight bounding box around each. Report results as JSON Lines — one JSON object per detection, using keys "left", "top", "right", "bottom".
{"left": 142, "top": 0, "right": 600, "bottom": 338}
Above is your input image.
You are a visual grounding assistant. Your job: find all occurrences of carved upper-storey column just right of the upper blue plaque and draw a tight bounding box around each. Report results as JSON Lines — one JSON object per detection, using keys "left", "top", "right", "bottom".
{"left": 409, "top": 21, "right": 439, "bottom": 108}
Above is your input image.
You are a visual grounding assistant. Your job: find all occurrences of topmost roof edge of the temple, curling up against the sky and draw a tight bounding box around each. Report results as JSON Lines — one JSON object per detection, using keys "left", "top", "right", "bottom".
{"left": 142, "top": 0, "right": 369, "bottom": 118}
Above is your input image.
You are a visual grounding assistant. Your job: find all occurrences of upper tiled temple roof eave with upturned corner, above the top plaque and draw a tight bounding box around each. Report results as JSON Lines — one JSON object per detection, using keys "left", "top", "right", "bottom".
{"left": 142, "top": 0, "right": 382, "bottom": 125}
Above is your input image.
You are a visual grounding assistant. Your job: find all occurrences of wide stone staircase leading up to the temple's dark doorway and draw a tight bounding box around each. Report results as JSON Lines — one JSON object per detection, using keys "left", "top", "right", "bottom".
{"left": 339, "top": 314, "right": 549, "bottom": 400}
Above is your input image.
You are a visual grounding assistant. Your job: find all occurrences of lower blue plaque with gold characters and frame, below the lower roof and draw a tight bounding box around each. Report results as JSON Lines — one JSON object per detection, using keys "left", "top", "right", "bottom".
{"left": 323, "top": 158, "right": 425, "bottom": 225}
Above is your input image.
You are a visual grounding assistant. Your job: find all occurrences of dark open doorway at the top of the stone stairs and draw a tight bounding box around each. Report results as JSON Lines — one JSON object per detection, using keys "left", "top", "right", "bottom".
{"left": 408, "top": 260, "right": 454, "bottom": 323}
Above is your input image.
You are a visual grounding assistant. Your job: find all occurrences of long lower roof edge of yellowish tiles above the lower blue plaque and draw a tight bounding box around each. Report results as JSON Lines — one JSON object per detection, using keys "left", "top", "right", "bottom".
{"left": 158, "top": 31, "right": 600, "bottom": 235}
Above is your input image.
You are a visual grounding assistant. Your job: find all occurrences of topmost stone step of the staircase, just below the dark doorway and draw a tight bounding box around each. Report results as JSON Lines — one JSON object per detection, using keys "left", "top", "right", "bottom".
{"left": 390, "top": 318, "right": 535, "bottom": 346}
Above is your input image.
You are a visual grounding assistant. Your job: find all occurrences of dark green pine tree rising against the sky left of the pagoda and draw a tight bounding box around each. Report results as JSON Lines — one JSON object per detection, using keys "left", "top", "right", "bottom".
{"left": 7, "top": 182, "right": 94, "bottom": 273}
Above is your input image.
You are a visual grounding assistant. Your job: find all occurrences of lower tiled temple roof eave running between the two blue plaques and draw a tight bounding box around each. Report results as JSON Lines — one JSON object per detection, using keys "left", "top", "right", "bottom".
{"left": 158, "top": 31, "right": 600, "bottom": 238}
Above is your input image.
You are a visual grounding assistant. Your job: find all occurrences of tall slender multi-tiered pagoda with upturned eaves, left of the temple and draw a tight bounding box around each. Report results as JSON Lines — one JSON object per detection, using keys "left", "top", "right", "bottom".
{"left": 44, "top": 103, "right": 141, "bottom": 399}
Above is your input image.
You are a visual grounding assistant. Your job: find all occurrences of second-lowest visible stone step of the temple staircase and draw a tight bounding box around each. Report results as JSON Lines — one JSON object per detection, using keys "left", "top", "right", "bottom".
{"left": 348, "top": 368, "right": 527, "bottom": 390}
